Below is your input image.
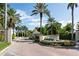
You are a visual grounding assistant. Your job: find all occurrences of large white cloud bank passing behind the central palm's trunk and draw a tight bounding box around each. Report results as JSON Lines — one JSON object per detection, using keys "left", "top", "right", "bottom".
{"left": 16, "top": 9, "right": 47, "bottom": 28}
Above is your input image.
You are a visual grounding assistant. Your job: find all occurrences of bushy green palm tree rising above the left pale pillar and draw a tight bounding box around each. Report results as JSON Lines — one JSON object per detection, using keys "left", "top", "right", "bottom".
{"left": 7, "top": 8, "right": 20, "bottom": 34}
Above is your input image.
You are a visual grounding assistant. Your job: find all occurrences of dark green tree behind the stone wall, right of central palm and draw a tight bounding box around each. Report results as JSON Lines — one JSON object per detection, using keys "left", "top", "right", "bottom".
{"left": 46, "top": 18, "right": 61, "bottom": 35}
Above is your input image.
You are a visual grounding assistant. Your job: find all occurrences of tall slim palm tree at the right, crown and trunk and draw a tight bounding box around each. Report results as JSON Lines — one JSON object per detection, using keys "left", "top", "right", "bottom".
{"left": 67, "top": 3, "right": 78, "bottom": 40}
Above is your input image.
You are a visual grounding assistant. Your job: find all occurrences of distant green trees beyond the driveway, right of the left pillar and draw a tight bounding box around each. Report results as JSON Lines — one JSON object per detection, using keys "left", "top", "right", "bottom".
{"left": 16, "top": 25, "right": 32, "bottom": 37}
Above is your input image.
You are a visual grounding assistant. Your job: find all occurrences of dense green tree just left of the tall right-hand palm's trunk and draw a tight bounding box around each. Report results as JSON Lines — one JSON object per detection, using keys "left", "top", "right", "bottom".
{"left": 59, "top": 23, "right": 75, "bottom": 40}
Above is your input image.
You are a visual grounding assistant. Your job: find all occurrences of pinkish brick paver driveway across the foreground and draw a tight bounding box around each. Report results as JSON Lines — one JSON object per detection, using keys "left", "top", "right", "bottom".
{"left": 1, "top": 38, "right": 79, "bottom": 56}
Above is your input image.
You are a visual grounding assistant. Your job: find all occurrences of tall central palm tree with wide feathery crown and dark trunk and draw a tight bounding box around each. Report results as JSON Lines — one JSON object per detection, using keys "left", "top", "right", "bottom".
{"left": 32, "top": 3, "right": 50, "bottom": 32}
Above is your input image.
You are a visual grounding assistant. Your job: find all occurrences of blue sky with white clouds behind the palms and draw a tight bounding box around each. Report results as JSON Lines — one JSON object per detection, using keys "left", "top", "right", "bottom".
{"left": 9, "top": 3, "right": 79, "bottom": 30}
